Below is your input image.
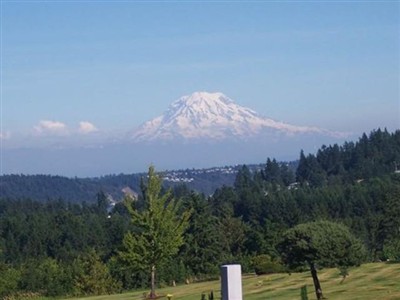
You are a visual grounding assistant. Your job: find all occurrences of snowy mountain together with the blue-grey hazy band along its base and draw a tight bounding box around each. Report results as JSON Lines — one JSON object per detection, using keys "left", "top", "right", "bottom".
{"left": 3, "top": 92, "right": 349, "bottom": 177}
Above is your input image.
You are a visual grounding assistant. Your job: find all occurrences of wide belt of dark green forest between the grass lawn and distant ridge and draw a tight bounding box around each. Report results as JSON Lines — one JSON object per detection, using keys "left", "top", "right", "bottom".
{"left": 0, "top": 129, "right": 400, "bottom": 297}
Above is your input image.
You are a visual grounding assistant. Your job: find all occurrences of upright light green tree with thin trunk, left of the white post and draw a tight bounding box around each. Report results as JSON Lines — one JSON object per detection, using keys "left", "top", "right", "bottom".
{"left": 118, "top": 166, "right": 190, "bottom": 298}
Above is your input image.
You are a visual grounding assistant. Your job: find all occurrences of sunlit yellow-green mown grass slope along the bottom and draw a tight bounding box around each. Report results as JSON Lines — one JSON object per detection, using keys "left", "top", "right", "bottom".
{"left": 65, "top": 263, "right": 400, "bottom": 300}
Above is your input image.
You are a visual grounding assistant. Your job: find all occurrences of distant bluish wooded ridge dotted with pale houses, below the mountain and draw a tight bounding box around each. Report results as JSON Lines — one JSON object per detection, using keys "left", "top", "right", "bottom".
{"left": 0, "top": 162, "right": 272, "bottom": 203}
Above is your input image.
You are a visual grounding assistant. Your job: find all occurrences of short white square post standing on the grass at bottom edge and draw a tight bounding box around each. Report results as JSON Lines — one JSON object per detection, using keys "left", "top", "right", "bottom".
{"left": 221, "top": 265, "right": 243, "bottom": 300}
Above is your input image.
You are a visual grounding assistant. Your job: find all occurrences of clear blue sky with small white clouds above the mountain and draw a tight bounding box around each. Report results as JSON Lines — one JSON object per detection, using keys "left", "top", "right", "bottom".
{"left": 0, "top": 0, "right": 400, "bottom": 147}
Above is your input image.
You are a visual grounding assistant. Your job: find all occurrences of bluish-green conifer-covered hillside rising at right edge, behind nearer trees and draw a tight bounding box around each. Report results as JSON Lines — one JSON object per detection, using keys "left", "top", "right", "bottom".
{"left": 296, "top": 129, "right": 400, "bottom": 186}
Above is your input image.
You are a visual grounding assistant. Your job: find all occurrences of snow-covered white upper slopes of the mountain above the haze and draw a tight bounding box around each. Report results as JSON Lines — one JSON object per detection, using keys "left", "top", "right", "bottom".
{"left": 133, "top": 92, "right": 334, "bottom": 142}
